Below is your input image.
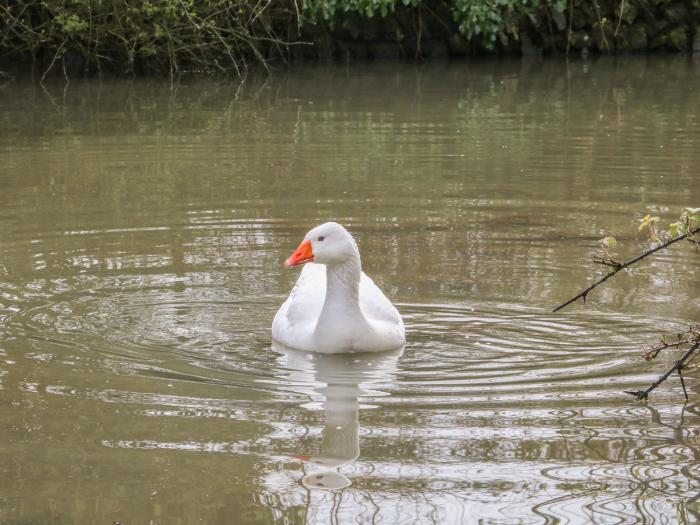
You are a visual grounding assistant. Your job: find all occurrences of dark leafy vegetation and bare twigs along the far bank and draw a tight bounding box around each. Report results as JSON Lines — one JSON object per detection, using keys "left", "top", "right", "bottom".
{"left": 0, "top": 0, "right": 700, "bottom": 75}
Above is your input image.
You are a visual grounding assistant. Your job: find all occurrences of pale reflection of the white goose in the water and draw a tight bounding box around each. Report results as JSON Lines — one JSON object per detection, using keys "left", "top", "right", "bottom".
{"left": 273, "top": 344, "right": 403, "bottom": 490}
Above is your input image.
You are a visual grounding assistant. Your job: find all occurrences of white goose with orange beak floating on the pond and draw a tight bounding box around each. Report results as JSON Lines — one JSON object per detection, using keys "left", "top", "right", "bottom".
{"left": 272, "top": 222, "right": 406, "bottom": 354}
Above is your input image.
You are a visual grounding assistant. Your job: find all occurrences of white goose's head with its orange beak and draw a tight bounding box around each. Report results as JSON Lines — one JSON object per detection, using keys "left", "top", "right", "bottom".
{"left": 284, "top": 222, "right": 360, "bottom": 268}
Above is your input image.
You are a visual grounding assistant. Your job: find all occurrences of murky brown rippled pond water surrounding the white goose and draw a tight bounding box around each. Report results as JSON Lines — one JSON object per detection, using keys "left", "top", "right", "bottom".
{"left": 0, "top": 57, "right": 700, "bottom": 525}
